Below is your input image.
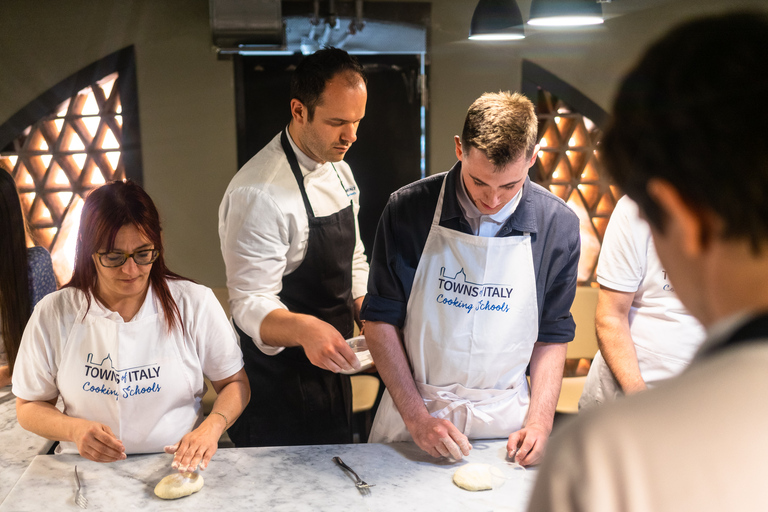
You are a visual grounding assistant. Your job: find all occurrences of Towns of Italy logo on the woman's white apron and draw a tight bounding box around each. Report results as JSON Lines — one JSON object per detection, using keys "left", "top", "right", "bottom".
{"left": 83, "top": 353, "right": 161, "bottom": 400}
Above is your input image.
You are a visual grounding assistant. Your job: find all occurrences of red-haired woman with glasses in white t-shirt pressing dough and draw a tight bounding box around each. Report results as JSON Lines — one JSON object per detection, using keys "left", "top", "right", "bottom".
{"left": 13, "top": 181, "right": 250, "bottom": 471}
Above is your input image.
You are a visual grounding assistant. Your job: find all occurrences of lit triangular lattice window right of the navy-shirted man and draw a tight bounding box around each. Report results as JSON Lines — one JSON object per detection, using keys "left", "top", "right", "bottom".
{"left": 534, "top": 88, "right": 622, "bottom": 282}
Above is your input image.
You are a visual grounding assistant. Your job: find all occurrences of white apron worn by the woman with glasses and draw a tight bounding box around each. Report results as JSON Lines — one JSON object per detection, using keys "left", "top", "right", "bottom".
{"left": 57, "top": 290, "right": 202, "bottom": 453}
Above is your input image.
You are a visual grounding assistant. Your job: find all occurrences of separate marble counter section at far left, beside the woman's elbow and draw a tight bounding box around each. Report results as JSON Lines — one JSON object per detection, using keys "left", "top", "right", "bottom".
{"left": 0, "top": 386, "right": 53, "bottom": 502}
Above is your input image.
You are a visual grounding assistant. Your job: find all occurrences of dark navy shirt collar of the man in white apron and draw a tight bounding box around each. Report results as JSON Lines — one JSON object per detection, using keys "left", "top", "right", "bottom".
{"left": 440, "top": 161, "right": 538, "bottom": 236}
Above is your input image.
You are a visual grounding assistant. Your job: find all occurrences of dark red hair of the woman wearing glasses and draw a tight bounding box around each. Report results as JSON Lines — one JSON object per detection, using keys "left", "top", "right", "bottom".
{"left": 64, "top": 180, "right": 186, "bottom": 331}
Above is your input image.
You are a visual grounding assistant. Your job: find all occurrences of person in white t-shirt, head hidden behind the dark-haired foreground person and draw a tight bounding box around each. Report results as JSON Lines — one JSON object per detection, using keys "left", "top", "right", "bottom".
{"left": 579, "top": 196, "right": 704, "bottom": 408}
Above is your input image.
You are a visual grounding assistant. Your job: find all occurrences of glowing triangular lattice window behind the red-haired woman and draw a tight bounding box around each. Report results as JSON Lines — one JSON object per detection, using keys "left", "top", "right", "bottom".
{"left": 0, "top": 73, "right": 125, "bottom": 282}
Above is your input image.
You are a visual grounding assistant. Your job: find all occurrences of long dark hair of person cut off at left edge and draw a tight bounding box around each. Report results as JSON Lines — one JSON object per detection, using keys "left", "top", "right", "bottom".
{"left": 0, "top": 166, "right": 32, "bottom": 373}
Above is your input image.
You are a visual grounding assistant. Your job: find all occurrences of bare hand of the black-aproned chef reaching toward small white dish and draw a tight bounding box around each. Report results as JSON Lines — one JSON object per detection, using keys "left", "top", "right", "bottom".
{"left": 299, "top": 317, "right": 360, "bottom": 373}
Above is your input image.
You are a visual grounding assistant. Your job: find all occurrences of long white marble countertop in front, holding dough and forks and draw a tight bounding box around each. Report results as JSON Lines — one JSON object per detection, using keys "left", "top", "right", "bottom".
{"left": 0, "top": 440, "right": 535, "bottom": 512}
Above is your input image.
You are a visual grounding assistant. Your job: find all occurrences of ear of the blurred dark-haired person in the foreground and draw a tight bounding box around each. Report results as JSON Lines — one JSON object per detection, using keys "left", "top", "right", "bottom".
{"left": 647, "top": 178, "right": 719, "bottom": 256}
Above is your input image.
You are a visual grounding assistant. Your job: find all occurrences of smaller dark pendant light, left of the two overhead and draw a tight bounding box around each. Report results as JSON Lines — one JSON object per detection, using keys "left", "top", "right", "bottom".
{"left": 469, "top": 0, "right": 525, "bottom": 41}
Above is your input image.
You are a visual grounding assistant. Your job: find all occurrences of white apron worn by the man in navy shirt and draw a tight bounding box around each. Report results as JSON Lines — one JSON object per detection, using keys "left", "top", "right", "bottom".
{"left": 370, "top": 175, "right": 538, "bottom": 443}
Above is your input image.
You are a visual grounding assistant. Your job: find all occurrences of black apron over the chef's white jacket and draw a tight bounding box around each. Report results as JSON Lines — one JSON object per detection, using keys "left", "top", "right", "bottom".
{"left": 229, "top": 129, "right": 355, "bottom": 447}
